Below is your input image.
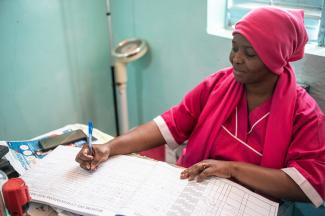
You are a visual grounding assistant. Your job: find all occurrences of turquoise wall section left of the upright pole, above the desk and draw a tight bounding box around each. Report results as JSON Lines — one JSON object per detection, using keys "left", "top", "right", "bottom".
{"left": 0, "top": 0, "right": 115, "bottom": 140}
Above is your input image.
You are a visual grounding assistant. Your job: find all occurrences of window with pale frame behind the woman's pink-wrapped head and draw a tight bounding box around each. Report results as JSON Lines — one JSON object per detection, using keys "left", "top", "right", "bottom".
{"left": 208, "top": 0, "right": 325, "bottom": 46}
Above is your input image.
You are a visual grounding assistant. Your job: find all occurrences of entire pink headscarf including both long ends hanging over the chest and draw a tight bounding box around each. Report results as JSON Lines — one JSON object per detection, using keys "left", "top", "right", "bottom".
{"left": 178, "top": 7, "right": 308, "bottom": 168}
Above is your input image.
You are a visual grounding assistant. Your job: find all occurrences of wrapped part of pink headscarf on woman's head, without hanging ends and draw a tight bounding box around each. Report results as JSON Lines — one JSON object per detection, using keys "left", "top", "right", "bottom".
{"left": 233, "top": 7, "right": 308, "bottom": 74}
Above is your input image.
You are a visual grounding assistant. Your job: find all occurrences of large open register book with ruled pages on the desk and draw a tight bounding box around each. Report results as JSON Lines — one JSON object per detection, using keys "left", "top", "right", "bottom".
{"left": 22, "top": 146, "right": 278, "bottom": 216}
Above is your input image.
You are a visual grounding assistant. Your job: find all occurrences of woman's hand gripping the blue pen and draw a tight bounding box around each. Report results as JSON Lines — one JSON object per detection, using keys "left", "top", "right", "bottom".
{"left": 76, "top": 144, "right": 111, "bottom": 171}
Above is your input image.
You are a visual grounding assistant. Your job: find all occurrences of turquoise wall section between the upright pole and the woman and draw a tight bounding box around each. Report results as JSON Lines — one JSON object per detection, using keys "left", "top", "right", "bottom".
{"left": 111, "top": 0, "right": 230, "bottom": 126}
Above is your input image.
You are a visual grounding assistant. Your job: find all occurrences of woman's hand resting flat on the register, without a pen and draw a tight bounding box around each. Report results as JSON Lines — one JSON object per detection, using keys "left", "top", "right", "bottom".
{"left": 181, "top": 160, "right": 232, "bottom": 182}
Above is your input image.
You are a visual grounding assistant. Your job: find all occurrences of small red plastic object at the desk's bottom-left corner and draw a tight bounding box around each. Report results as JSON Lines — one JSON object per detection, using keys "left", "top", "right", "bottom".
{"left": 2, "top": 178, "right": 31, "bottom": 216}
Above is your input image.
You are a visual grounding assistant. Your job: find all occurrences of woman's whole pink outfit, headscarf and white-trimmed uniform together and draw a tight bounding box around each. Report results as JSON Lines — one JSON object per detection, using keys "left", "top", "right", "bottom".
{"left": 155, "top": 7, "right": 325, "bottom": 206}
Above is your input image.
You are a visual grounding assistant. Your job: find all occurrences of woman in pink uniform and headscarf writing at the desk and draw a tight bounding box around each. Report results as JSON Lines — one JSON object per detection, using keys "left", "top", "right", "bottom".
{"left": 76, "top": 7, "right": 325, "bottom": 206}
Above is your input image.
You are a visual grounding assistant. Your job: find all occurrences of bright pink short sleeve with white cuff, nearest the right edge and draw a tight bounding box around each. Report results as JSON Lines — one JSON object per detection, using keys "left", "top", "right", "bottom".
{"left": 283, "top": 88, "right": 325, "bottom": 206}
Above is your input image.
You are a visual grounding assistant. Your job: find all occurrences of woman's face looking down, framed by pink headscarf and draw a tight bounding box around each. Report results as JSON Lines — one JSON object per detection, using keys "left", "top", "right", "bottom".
{"left": 229, "top": 34, "right": 274, "bottom": 84}
